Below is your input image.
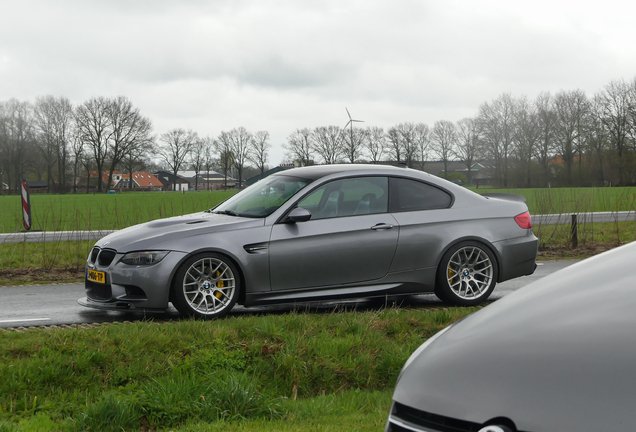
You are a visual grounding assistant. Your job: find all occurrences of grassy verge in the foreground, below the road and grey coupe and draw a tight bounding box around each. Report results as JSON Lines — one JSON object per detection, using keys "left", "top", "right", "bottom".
{"left": 0, "top": 308, "right": 476, "bottom": 431}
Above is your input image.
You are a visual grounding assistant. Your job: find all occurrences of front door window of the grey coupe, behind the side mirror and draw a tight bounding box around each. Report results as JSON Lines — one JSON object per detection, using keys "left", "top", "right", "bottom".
{"left": 298, "top": 177, "right": 389, "bottom": 220}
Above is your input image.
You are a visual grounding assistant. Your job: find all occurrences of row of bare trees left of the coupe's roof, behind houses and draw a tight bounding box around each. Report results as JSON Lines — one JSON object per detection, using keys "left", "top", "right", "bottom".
{"left": 0, "top": 95, "right": 271, "bottom": 192}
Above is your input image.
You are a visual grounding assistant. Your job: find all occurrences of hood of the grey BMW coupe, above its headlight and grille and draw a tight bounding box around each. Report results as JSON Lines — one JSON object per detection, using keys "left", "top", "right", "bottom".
{"left": 96, "top": 212, "right": 265, "bottom": 253}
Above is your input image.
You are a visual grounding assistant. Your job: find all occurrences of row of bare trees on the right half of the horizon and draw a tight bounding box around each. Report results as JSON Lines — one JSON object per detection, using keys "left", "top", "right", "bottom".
{"left": 284, "top": 79, "right": 636, "bottom": 187}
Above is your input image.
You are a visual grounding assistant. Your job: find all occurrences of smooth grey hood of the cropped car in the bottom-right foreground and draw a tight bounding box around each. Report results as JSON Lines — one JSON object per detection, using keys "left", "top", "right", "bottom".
{"left": 394, "top": 243, "right": 636, "bottom": 432}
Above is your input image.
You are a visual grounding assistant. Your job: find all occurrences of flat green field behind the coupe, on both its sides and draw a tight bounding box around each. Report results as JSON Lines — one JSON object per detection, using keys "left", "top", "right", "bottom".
{"left": 0, "top": 187, "right": 636, "bottom": 233}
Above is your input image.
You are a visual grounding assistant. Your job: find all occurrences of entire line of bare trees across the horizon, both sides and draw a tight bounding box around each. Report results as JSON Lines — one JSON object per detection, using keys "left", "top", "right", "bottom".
{"left": 0, "top": 79, "right": 636, "bottom": 191}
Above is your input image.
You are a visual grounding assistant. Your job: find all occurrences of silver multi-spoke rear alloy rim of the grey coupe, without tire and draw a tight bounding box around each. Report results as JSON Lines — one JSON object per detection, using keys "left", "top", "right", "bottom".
{"left": 446, "top": 246, "right": 493, "bottom": 300}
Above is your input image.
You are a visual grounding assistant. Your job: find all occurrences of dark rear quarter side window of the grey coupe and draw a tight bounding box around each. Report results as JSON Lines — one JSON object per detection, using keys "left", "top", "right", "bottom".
{"left": 390, "top": 178, "right": 453, "bottom": 213}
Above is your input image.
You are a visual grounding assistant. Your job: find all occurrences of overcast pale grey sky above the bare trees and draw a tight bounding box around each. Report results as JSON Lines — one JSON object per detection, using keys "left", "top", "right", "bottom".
{"left": 0, "top": 0, "right": 636, "bottom": 165}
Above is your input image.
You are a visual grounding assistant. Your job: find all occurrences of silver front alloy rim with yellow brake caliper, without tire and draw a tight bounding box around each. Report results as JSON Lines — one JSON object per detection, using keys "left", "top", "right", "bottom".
{"left": 183, "top": 257, "right": 236, "bottom": 315}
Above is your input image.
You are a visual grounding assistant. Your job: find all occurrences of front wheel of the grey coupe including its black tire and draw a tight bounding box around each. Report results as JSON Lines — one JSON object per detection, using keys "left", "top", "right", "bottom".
{"left": 170, "top": 252, "right": 241, "bottom": 319}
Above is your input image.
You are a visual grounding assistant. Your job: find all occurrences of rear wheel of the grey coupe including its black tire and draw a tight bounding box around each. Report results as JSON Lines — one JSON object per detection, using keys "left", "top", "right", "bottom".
{"left": 435, "top": 241, "right": 498, "bottom": 306}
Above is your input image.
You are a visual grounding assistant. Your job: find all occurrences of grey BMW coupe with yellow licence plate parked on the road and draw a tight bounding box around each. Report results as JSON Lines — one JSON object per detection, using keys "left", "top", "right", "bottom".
{"left": 78, "top": 165, "right": 537, "bottom": 318}
